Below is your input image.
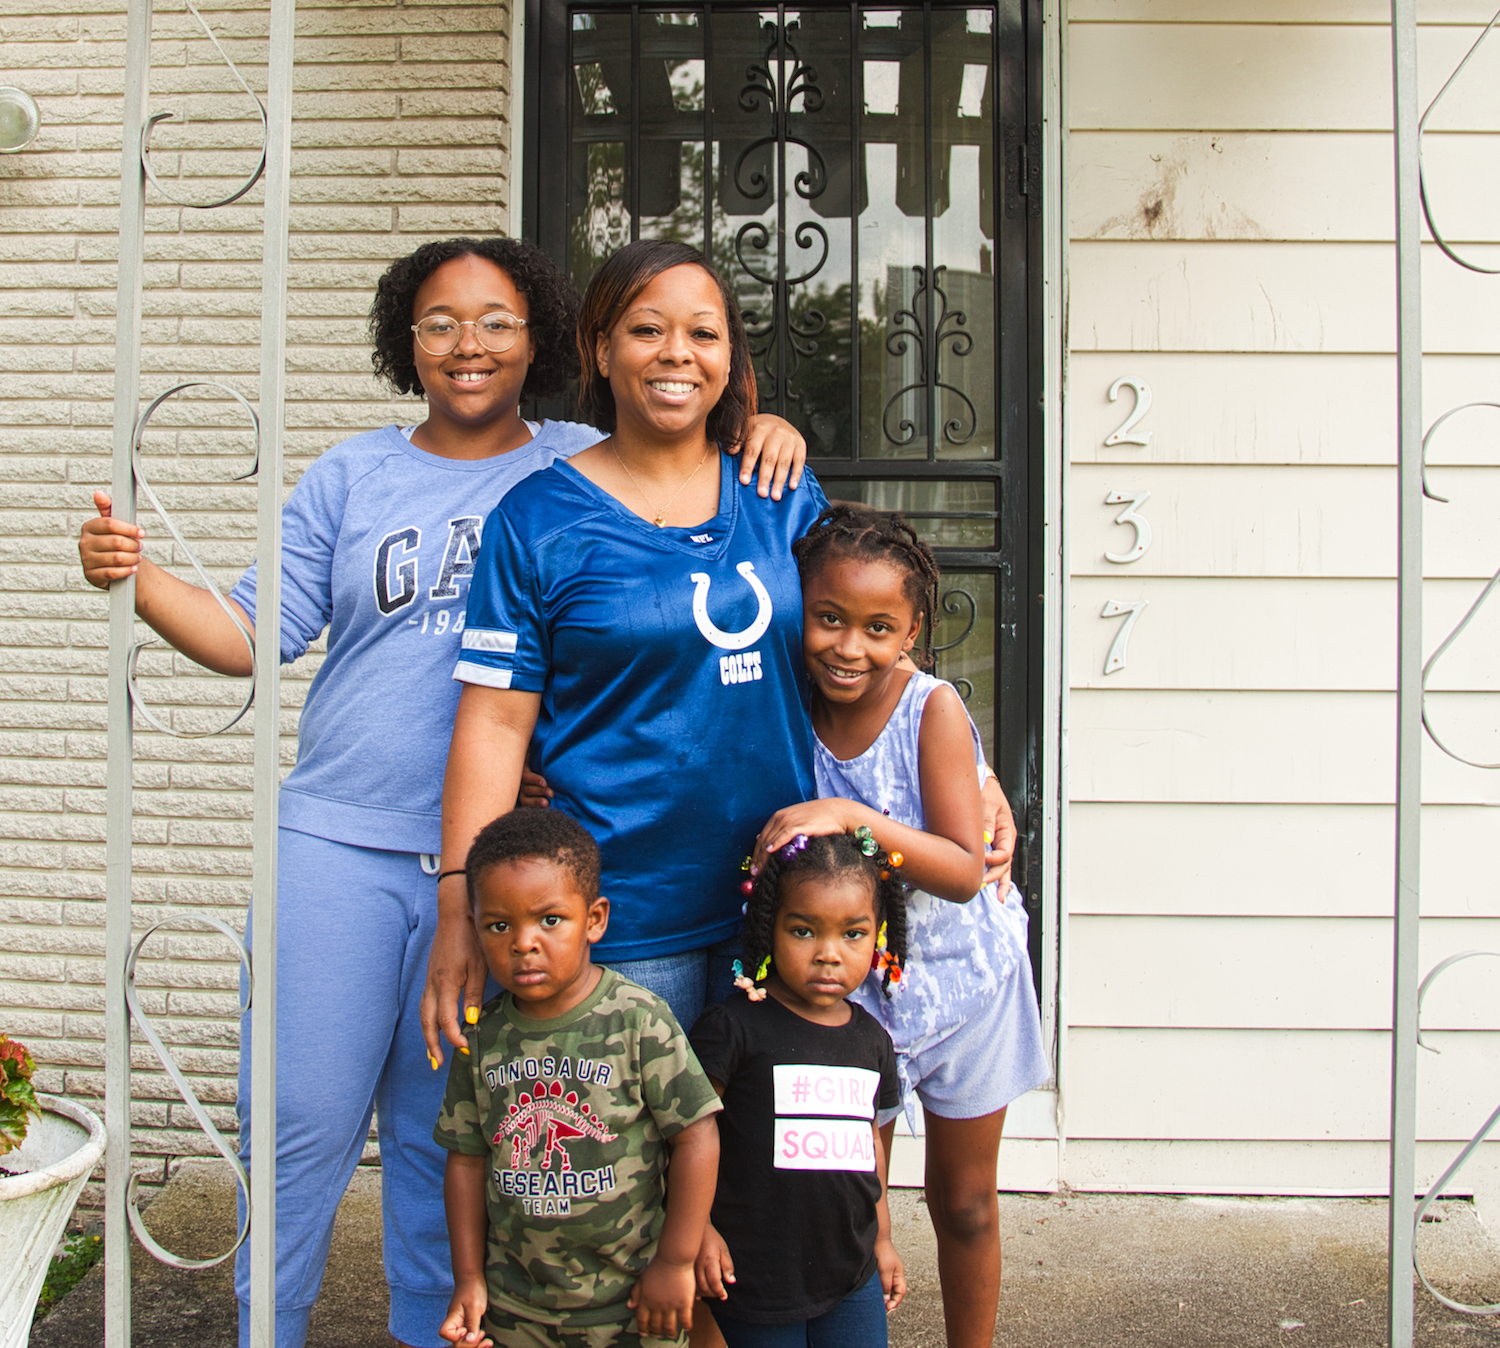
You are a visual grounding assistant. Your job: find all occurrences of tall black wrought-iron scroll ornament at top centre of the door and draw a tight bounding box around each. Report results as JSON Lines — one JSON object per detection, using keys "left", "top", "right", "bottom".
{"left": 734, "top": 22, "right": 828, "bottom": 402}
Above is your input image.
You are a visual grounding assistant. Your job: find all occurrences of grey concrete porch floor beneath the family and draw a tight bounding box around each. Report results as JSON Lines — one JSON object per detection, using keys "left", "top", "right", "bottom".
{"left": 20, "top": 1162, "right": 1500, "bottom": 1348}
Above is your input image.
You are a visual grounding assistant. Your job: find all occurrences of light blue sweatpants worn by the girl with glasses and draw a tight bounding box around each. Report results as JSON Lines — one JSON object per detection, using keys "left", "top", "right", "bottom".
{"left": 234, "top": 829, "right": 453, "bottom": 1348}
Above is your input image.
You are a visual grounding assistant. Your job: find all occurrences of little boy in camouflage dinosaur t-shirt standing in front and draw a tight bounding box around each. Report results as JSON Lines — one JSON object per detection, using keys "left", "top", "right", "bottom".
{"left": 434, "top": 810, "right": 720, "bottom": 1348}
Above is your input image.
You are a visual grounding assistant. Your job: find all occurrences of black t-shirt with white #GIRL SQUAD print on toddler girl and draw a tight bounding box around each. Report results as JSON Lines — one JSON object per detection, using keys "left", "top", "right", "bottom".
{"left": 689, "top": 993, "right": 900, "bottom": 1324}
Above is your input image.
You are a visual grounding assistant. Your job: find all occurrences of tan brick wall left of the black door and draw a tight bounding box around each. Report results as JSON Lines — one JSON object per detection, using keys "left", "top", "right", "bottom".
{"left": 0, "top": 0, "right": 512, "bottom": 1205}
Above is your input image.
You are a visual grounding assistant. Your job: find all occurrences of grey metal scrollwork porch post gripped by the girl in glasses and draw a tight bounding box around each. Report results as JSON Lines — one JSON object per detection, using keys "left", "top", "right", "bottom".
{"left": 105, "top": 0, "right": 296, "bottom": 1348}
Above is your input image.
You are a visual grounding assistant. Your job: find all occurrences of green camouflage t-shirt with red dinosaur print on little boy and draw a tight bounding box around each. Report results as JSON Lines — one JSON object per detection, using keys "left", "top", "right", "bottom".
{"left": 432, "top": 969, "right": 720, "bottom": 1324}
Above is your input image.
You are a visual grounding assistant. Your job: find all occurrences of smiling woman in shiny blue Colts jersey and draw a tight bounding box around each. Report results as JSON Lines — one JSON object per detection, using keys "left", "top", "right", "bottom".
{"left": 423, "top": 240, "right": 824, "bottom": 1057}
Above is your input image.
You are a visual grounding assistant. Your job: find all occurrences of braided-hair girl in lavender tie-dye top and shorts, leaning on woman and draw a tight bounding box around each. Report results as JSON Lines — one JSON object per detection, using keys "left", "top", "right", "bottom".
{"left": 755, "top": 504, "right": 1050, "bottom": 1348}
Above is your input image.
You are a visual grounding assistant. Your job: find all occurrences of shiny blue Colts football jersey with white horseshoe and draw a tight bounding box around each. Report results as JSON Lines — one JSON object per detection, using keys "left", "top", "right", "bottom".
{"left": 453, "top": 456, "right": 828, "bottom": 960}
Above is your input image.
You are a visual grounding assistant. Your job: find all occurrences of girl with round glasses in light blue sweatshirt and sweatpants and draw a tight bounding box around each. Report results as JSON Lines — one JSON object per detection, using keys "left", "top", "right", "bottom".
{"left": 80, "top": 238, "right": 806, "bottom": 1348}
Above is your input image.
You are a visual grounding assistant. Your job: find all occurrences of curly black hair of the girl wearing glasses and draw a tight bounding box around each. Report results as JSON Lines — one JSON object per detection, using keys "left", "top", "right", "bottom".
{"left": 369, "top": 238, "right": 579, "bottom": 397}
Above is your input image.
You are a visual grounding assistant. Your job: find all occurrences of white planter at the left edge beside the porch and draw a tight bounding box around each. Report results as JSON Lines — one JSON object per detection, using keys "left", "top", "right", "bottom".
{"left": 0, "top": 1093, "right": 105, "bottom": 1348}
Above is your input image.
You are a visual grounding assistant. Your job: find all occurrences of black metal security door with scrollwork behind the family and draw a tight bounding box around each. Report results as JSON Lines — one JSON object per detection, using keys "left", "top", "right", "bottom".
{"left": 524, "top": 0, "right": 1043, "bottom": 967}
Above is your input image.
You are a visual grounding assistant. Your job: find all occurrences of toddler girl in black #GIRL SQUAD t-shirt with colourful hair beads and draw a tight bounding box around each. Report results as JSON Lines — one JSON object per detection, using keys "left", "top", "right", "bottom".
{"left": 689, "top": 829, "right": 906, "bottom": 1348}
